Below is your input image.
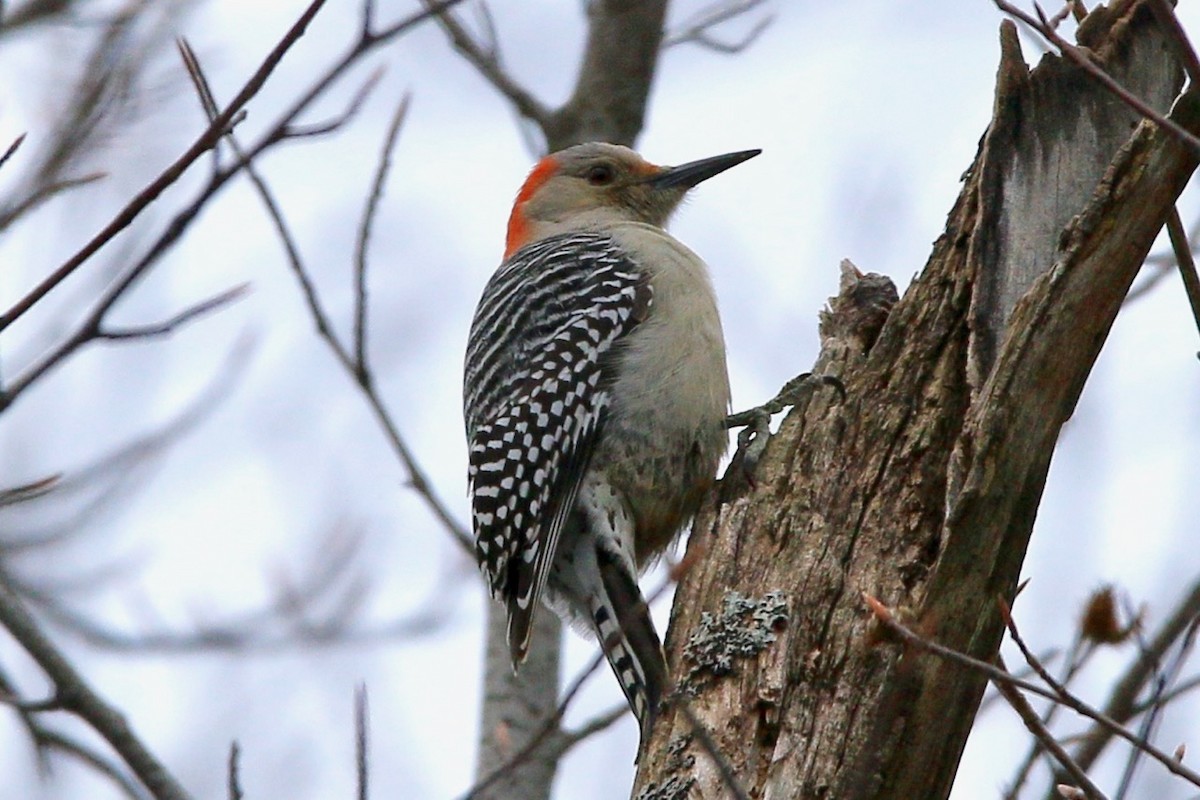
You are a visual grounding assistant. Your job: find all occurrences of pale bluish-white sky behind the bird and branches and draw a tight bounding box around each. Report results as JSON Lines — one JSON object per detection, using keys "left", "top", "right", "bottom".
{"left": 0, "top": 0, "right": 1200, "bottom": 800}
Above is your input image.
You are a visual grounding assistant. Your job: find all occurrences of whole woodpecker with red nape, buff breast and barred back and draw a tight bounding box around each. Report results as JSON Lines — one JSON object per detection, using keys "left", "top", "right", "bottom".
{"left": 463, "top": 143, "right": 761, "bottom": 739}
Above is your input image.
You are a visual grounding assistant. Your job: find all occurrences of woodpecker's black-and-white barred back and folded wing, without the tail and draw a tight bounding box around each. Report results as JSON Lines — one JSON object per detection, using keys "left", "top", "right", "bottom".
{"left": 463, "top": 231, "right": 652, "bottom": 664}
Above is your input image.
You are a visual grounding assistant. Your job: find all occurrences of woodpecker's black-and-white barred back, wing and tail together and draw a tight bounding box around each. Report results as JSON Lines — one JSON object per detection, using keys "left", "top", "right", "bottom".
{"left": 463, "top": 231, "right": 666, "bottom": 734}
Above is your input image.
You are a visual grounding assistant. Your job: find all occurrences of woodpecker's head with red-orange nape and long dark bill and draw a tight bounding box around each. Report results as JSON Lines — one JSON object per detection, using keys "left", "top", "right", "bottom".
{"left": 504, "top": 142, "right": 762, "bottom": 258}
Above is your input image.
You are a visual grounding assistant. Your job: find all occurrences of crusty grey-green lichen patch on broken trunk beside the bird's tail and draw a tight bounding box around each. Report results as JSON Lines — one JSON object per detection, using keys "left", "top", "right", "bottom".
{"left": 679, "top": 591, "right": 787, "bottom": 694}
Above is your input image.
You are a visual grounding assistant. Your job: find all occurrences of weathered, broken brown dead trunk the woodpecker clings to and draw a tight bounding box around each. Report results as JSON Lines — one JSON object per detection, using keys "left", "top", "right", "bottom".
{"left": 635, "top": 2, "right": 1200, "bottom": 800}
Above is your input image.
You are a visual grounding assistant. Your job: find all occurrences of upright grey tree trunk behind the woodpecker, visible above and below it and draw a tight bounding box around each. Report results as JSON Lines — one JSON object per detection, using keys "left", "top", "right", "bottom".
{"left": 463, "top": 0, "right": 667, "bottom": 800}
